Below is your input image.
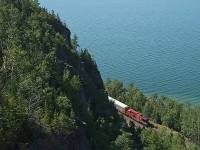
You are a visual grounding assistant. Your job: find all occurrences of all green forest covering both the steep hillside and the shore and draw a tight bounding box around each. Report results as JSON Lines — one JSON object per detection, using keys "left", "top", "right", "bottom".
{"left": 0, "top": 0, "right": 200, "bottom": 150}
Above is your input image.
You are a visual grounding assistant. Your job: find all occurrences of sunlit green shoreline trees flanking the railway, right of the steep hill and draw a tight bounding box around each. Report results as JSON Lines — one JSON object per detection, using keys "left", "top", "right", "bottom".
{"left": 105, "top": 78, "right": 200, "bottom": 150}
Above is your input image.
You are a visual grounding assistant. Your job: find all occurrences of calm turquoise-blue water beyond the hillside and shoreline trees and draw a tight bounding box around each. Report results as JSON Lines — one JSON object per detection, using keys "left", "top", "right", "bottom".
{"left": 39, "top": 0, "right": 200, "bottom": 105}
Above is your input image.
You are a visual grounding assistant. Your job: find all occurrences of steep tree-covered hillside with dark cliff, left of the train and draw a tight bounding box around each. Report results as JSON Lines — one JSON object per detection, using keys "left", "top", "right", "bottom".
{"left": 0, "top": 0, "right": 121, "bottom": 150}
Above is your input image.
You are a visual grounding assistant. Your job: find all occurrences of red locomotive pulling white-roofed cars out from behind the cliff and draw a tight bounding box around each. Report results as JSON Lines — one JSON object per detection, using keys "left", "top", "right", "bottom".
{"left": 108, "top": 96, "right": 149, "bottom": 126}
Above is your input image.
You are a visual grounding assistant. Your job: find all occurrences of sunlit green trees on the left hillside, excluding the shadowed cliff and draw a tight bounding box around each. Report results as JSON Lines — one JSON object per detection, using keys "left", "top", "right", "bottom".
{"left": 0, "top": 0, "right": 81, "bottom": 149}
